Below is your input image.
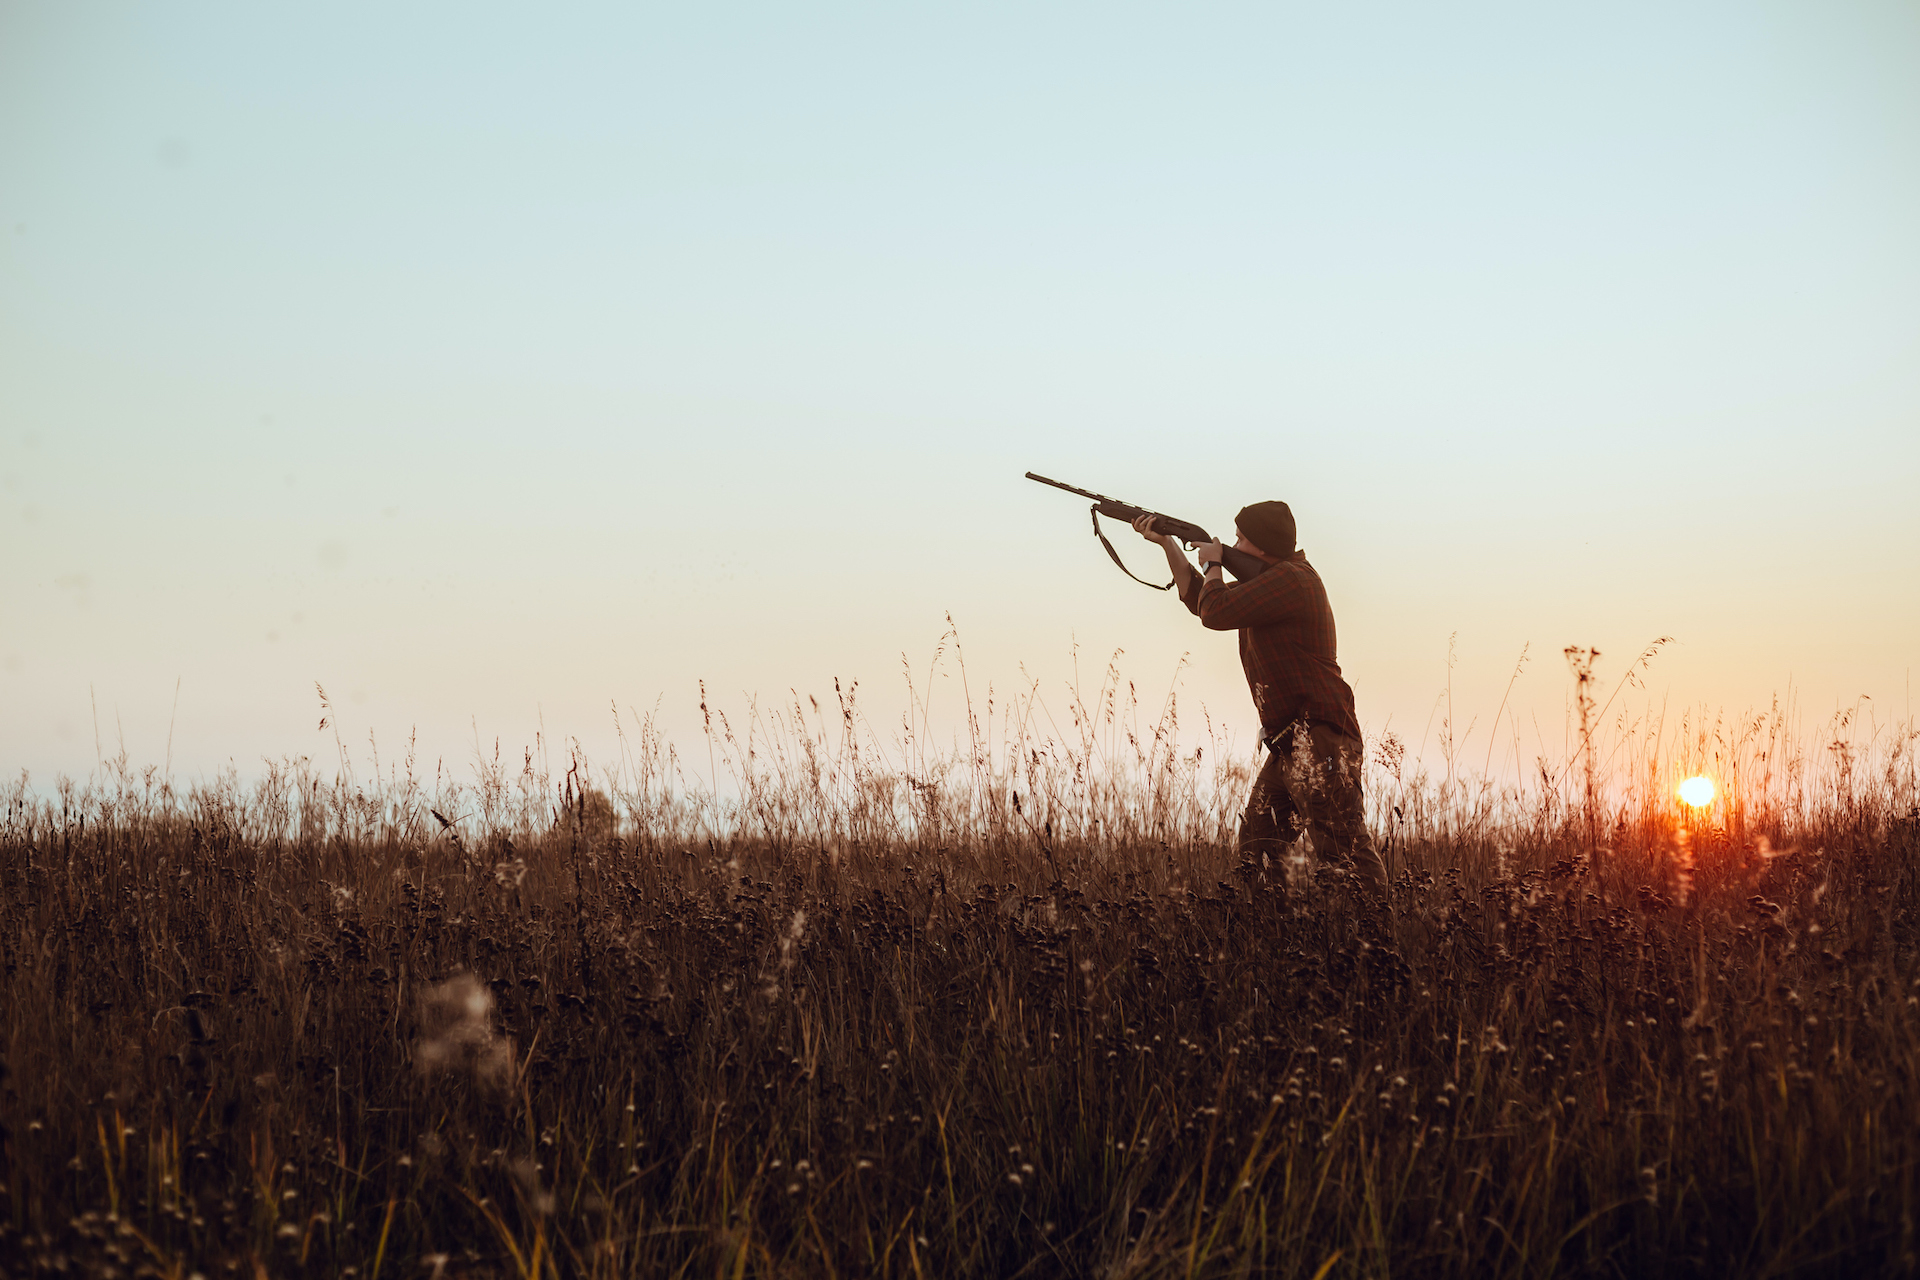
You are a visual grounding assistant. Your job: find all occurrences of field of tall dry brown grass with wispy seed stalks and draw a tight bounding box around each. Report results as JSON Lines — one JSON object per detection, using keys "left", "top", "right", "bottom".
{"left": 0, "top": 668, "right": 1920, "bottom": 1278}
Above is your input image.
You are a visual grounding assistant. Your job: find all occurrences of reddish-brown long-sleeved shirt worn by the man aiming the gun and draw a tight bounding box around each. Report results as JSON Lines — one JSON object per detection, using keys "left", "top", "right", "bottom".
{"left": 1181, "top": 551, "right": 1359, "bottom": 739}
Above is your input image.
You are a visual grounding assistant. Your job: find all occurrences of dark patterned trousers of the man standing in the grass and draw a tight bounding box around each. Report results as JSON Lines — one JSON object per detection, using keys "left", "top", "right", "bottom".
{"left": 1240, "top": 720, "right": 1386, "bottom": 898}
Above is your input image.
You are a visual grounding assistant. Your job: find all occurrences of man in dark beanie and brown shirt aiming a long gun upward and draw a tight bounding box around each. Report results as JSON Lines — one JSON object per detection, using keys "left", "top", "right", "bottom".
{"left": 1133, "top": 503, "right": 1386, "bottom": 898}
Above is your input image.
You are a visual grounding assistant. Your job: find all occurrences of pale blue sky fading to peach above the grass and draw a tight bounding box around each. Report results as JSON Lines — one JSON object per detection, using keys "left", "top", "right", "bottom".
{"left": 0, "top": 0, "right": 1920, "bottom": 789}
